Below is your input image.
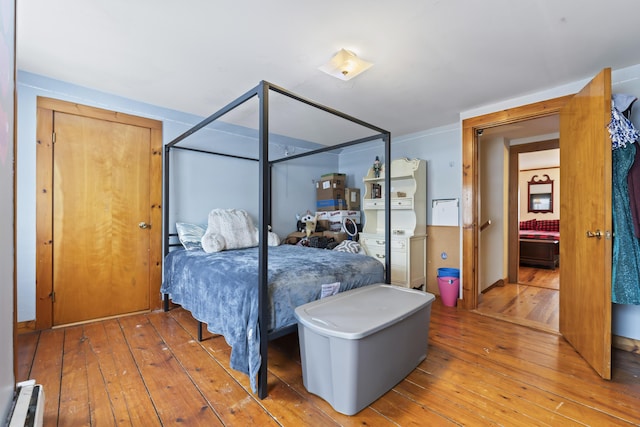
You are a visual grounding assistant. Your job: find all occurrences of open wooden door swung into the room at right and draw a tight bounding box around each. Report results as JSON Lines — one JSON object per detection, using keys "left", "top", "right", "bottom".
{"left": 560, "top": 69, "right": 612, "bottom": 379}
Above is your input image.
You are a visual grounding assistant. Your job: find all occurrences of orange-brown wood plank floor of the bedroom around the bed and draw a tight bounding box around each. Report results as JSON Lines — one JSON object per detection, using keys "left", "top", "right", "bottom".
{"left": 18, "top": 299, "right": 640, "bottom": 426}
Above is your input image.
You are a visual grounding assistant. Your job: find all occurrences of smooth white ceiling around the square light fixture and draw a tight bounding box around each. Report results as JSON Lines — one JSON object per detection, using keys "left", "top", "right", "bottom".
{"left": 17, "top": 0, "right": 640, "bottom": 141}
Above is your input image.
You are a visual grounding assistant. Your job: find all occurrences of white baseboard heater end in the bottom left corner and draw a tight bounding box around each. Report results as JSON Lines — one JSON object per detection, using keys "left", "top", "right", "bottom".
{"left": 8, "top": 380, "right": 44, "bottom": 427}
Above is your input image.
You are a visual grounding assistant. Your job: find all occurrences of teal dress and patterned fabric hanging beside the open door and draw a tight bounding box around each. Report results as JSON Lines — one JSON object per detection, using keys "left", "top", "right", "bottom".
{"left": 609, "top": 95, "right": 640, "bottom": 305}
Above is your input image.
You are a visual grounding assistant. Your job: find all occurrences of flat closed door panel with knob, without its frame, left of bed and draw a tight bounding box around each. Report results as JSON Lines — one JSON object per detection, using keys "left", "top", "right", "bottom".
{"left": 53, "top": 112, "right": 150, "bottom": 325}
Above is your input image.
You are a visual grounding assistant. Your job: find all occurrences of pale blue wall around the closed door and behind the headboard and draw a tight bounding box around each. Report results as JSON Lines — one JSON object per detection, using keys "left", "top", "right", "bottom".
{"left": 15, "top": 72, "right": 338, "bottom": 322}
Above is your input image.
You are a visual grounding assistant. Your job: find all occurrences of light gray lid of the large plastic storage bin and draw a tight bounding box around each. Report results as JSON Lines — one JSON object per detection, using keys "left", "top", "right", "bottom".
{"left": 295, "top": 284, "right": 435, "bottom": 339}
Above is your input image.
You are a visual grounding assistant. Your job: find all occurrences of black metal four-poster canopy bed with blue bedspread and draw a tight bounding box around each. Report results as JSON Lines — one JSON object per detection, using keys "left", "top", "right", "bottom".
{"left": 161, "top": 81, "right": 391, "bottom": 398}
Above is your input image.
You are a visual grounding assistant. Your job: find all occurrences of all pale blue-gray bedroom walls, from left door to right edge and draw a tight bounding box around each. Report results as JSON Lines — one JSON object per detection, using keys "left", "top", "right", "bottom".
{"left": 17, "top": 65, "right": 640, "bottom": 339}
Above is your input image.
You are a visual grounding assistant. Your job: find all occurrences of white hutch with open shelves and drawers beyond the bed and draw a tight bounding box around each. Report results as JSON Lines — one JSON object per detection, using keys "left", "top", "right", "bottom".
{"left": 360, "top": 159, "right": 427, "bottom": 290}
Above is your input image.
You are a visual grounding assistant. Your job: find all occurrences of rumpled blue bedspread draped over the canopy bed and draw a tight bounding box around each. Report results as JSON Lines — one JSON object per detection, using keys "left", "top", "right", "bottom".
{"left": 161, "top": 245, "right": 384, "bottom": 392}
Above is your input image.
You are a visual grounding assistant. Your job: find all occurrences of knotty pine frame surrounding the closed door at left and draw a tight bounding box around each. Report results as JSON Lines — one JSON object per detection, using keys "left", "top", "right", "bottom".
{"left": 35, "top": 97, "right": 163, "bottom": 330}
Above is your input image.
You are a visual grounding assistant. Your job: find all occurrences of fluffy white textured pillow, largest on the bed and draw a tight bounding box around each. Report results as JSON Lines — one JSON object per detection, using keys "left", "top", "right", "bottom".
{"left": 202, "top": 209, "right": 258, "bottom": 252}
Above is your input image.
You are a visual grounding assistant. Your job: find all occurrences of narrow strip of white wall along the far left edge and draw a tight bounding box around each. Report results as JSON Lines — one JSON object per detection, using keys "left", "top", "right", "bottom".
{"left": 0, "top": 0, "right": 15, "bottom": 422}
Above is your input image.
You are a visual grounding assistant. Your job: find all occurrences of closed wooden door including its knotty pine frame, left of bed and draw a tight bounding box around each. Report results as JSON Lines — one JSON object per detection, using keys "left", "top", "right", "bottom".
{"left": 36, "top": 100, "right": 162, "bottom": 328}
